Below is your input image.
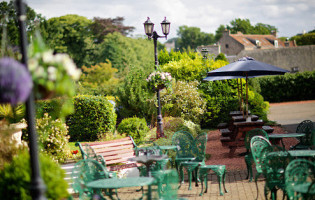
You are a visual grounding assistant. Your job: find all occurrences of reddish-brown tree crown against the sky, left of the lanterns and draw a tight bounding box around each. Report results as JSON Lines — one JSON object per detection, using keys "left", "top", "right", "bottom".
{"left": 90, "top": 17, "right": 135, "bottom": 43}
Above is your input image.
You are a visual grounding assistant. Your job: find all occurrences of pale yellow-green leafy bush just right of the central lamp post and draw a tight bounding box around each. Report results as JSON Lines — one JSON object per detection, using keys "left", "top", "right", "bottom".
{"left": 161, "top": 81, "right": 206, "bottom": 123}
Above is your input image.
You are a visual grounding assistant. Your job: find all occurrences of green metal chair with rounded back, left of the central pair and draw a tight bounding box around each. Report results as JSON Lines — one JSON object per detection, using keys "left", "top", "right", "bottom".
{"left": 172, "top": 131, "right": 196, "bottom": 181}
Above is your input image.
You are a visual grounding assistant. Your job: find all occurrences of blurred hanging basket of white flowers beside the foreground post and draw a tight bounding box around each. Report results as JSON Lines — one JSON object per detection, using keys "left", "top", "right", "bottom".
{"left": 28, "top": 32, "right": 81, "bottom": 99}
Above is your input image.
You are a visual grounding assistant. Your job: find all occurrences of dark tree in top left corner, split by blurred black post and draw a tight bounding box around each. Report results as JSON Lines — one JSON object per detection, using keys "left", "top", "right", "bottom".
{"left": 0, "top": 1, "right": 46, "bottom": 46}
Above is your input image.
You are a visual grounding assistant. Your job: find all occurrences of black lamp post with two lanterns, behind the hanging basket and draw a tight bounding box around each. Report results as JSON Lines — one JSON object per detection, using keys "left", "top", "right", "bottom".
{"left": 144, "top": 17, "right": 171, "bottom": 138}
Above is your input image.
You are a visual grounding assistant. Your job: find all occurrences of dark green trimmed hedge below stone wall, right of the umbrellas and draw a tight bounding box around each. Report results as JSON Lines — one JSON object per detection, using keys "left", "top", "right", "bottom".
{"left": 257, "top": 71, "right": 315, "bottom": 102}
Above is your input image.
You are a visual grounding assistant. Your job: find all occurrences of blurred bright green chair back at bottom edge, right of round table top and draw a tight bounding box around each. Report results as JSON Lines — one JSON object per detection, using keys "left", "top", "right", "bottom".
{"left": 152, "top": 169, "right": 179, "bottom": 200}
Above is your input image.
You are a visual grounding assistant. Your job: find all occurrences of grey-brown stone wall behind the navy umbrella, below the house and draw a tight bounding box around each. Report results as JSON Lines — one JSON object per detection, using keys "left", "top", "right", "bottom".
{"left": 236, "top": 45, "right": 315, "bottom": 72}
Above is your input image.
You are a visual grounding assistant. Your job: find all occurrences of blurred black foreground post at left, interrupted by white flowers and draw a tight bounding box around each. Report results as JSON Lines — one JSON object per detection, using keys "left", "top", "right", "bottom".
{"left": 16, "top": 0, "right": 46, "bottom": 200}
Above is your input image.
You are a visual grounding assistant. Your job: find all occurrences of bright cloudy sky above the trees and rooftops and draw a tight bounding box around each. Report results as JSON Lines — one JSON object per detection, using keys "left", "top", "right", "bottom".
{"left": 25, "top": 0, "right": 315, "bottom": 39}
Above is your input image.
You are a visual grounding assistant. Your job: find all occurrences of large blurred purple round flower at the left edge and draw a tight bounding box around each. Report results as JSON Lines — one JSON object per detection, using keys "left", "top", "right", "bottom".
{"left": 0, "top": 57, "right": 33, "bottom": 105}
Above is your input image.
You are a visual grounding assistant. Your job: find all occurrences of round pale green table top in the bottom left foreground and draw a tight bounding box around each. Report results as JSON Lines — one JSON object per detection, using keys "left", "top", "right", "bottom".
{"left": 86, "top": 177, "right": 154, "bottom": 189}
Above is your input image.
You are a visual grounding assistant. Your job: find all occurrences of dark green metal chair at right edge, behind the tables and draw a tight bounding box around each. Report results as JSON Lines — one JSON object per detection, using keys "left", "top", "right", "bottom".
{"left": 290, "top": 120, "right": 315, "bottom": 150}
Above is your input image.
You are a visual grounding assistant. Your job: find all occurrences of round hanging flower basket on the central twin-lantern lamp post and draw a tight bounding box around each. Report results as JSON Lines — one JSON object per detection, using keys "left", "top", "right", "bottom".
{"left": 146, "top": 71, "right": 172, "bottom": 90}
